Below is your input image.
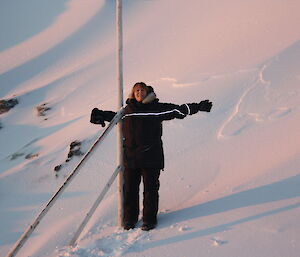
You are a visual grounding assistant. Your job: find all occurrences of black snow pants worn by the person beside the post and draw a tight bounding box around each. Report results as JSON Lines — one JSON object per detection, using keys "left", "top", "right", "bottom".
{"left": 123, "top": 167, "right": 160, "bottom": 224}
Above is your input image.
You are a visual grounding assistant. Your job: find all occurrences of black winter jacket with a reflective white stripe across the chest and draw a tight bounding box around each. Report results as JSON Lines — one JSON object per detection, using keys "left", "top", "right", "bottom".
{"left": 101, "top": 95, "right": 197, "bottom": 169}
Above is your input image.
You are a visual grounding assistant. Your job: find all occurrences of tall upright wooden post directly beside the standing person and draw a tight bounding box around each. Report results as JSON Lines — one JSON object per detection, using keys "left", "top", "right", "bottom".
{"left": 116, "top": 0, "right": 124, "bottom": 226}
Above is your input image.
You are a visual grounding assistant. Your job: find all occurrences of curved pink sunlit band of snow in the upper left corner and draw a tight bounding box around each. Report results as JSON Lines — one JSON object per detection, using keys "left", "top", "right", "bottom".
{"left": 0, "top": 0, "right": 105, "bottom": 73}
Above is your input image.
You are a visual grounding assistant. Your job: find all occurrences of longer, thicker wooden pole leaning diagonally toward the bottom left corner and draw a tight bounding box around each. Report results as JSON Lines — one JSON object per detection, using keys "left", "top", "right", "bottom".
{"left": 6, "top": 108, "right": 124, "bottom": 257}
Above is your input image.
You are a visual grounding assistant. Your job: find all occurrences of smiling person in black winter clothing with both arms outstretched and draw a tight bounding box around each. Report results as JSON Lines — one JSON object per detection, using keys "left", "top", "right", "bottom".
{"left": 90, "top": 82, "right": 212, "bottom": 231}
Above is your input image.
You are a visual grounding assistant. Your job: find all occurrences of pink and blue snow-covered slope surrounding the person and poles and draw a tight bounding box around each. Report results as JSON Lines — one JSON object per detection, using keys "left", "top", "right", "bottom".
{"left": 0, "top": 0, "right": 300, "bottom": 257}
